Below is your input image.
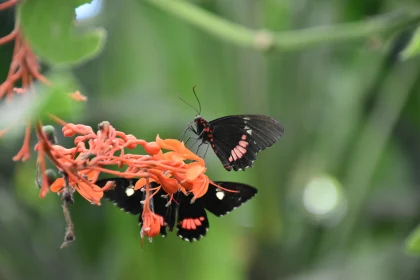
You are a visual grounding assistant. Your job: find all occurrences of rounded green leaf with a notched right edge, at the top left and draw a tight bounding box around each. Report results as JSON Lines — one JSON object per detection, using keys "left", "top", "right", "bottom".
{"left": 19, "top": 0, "right": 106, "bottom": 66}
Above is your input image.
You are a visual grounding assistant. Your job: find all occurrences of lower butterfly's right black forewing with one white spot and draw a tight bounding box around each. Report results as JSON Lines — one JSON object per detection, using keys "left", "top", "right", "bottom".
{"left": 198, "top": 182, "right": 258, "bottom": 217}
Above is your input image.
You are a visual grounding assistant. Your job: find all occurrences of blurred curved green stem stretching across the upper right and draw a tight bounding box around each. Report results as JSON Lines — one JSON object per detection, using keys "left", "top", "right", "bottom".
{"left": 146, "top": 0, "right": 420, "bottom": 51}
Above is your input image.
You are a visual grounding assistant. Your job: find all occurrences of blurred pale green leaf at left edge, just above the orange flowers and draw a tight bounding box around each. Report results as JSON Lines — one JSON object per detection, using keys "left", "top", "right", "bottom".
{"left": 0, "top": 71, "right": 85, "bottom": 132}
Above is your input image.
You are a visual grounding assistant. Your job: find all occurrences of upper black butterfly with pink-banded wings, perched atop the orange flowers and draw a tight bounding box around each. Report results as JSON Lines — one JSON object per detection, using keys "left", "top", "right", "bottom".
{"left": 194, "top": 115, "right": 284, "bottom": 171}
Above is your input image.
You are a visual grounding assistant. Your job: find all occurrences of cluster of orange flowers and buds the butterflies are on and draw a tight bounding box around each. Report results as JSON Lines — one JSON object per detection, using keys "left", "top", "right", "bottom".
{"left": 35, "top": 117, "right": 210, "bottom": 240}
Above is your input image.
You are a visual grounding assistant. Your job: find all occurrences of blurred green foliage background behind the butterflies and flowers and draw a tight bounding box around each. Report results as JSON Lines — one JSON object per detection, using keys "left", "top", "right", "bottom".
{"left": 0, "top": 0, "right": 420, "bottom": 280}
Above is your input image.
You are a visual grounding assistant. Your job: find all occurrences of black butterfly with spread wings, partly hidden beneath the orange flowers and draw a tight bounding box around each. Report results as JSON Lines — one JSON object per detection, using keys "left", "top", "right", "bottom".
{"left": 95, "top": 178, "right": 257, "bottom": 242}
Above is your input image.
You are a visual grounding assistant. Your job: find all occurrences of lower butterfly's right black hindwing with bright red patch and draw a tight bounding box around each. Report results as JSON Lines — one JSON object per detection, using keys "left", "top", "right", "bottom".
{"left": 177, "top": 195, "right": 210, "bottom": 242}
